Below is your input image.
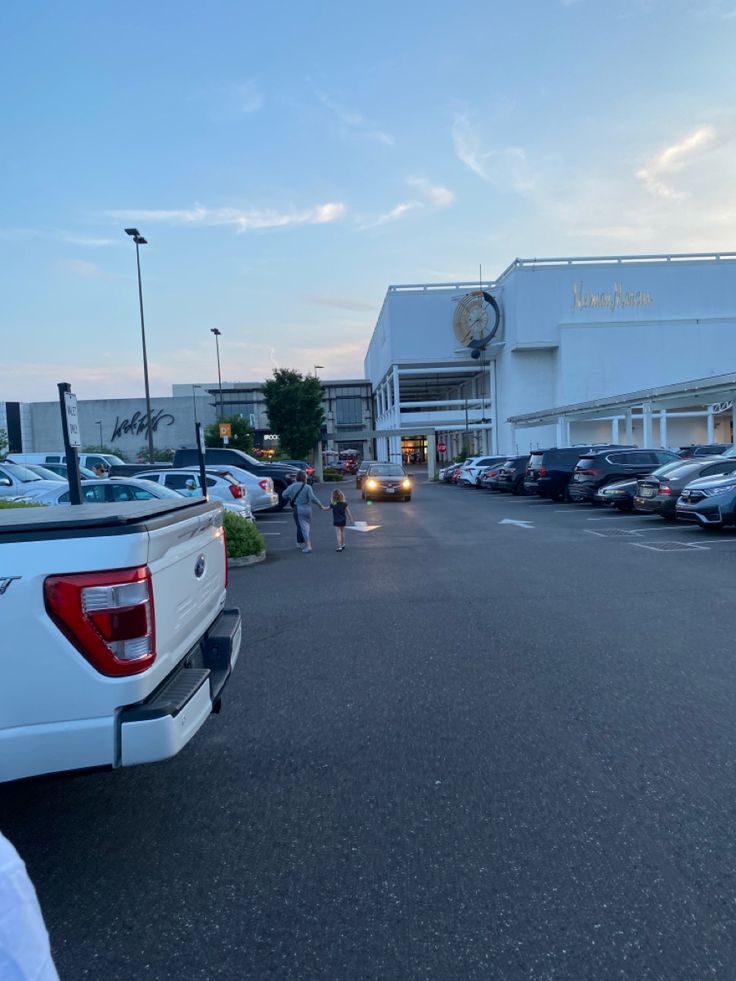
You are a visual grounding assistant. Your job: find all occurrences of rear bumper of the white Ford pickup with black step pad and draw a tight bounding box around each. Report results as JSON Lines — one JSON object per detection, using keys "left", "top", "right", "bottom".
{"left": 119, "top": 610, "right": 242, "bottom": 766}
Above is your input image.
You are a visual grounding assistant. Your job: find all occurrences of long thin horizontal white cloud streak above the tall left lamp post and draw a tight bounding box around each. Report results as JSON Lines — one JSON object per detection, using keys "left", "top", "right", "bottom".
{"left": 105, "top": 201, "right": 346, "bottom": 232}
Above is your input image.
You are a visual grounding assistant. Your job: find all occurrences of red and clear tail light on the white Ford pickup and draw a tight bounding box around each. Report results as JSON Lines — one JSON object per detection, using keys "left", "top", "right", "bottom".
{"left": 43, "top": 566, "right": 156, "bottom": 678}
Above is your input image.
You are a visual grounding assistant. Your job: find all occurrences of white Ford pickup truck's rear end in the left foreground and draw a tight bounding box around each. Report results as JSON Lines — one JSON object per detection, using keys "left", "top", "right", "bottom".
{"left": 0, "top": 498, "right": 241, "bottom": 782}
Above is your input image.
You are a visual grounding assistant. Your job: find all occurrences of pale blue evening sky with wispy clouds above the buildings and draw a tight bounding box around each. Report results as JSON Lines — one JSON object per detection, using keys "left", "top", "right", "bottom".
{"left": 0, "top": 0, "right": 736, "bottom": 401}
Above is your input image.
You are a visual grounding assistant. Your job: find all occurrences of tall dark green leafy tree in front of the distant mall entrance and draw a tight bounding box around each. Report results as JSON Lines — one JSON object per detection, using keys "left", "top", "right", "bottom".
{"left": 263, "top": 368, "right": 324, "bottom": 460}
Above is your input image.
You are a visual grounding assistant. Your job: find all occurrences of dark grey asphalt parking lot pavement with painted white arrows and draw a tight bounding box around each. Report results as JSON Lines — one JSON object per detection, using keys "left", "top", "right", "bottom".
{"left": 0, "top": 479, "right": 736, "bottom": 981}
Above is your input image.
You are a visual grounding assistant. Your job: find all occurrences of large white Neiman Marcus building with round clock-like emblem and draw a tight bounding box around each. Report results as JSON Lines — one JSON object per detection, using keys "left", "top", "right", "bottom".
{"left": 365, "top": 253, "right": 736, "bottom": 467}
